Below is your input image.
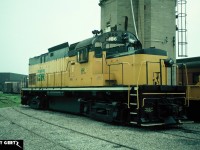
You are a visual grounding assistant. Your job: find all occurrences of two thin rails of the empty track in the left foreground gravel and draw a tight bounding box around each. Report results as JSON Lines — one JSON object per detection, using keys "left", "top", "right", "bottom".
{"left": 6, "top": 107, "right": 136, "bottom": 150}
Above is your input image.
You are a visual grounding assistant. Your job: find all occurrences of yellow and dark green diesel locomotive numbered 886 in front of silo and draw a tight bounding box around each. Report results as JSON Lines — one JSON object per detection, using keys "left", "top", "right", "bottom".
{"left": 21, "top": 31, "right": 187, "bottom": 126}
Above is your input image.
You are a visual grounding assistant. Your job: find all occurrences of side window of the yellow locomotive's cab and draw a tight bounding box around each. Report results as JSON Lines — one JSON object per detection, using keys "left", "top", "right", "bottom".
{"left": 77, "top": 48, "right": 88, "bottom": 63}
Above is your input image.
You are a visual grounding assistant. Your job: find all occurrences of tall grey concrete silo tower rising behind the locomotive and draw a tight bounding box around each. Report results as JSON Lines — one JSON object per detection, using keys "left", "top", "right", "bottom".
{"left": 99, "top": 0, "right": 176, "bottom": 60}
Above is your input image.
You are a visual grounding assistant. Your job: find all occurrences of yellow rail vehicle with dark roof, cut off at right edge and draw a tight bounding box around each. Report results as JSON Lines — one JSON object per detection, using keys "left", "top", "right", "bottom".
{"left": 177, "top": 57, "right": 200, "bottom": 120}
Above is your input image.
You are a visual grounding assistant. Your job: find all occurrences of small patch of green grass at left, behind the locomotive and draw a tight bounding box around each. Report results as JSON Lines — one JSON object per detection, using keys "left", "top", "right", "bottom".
{"left": 0, "top": 92, "right": 21, "bottom": 108}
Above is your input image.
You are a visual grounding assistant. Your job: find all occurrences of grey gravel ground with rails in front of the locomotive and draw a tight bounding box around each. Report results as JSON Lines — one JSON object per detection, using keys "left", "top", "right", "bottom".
{"left": 0, "top": 106, "right": 200, "bottom": 150}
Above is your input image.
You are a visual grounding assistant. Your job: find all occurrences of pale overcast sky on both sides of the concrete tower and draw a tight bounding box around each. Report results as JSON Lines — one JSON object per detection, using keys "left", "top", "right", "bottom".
{"left": 0, "top": 0, "right": 200, "bottom": 74}
